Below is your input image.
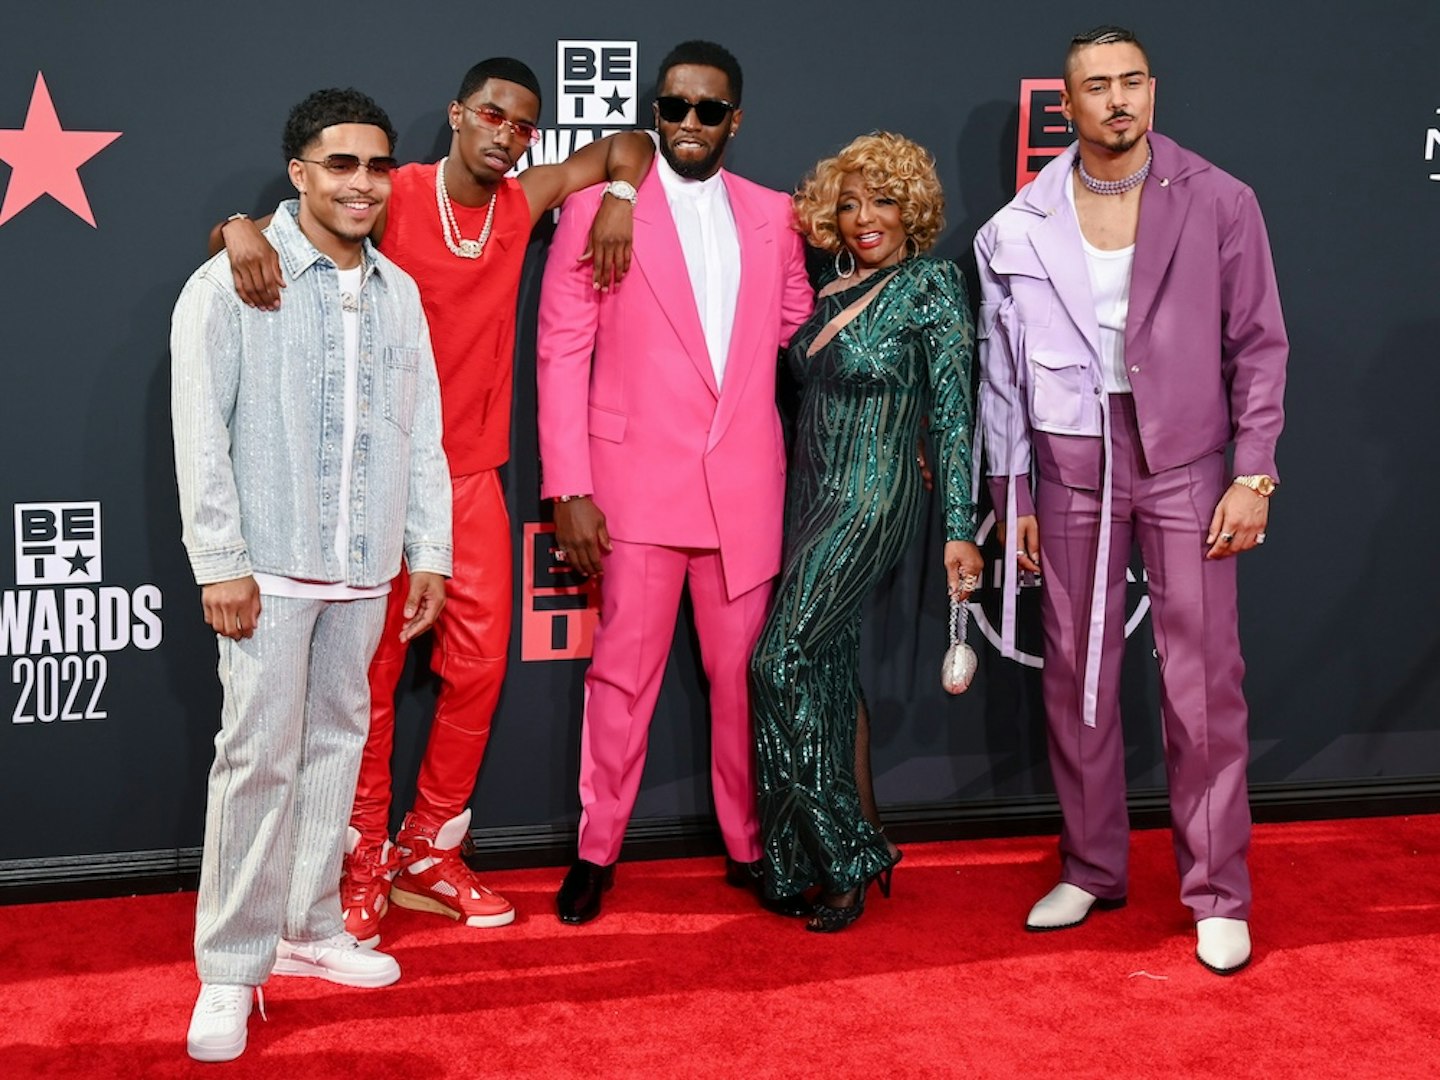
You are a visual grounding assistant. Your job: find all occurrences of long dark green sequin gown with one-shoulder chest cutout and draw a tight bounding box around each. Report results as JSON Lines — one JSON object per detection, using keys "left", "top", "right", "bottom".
{"left": 750, "top": 258, "right": 975, "bottom": 897}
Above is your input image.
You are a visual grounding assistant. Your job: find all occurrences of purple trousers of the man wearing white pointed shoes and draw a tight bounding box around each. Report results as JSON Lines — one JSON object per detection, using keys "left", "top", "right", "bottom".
{"left": 1034, "top": 395, "right": 1250, "bottom": 920}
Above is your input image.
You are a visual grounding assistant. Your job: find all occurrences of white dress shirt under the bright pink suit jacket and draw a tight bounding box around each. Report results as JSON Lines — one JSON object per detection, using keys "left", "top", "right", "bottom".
{"left": 655, "top": 154, "right": 740, "bottom": 386}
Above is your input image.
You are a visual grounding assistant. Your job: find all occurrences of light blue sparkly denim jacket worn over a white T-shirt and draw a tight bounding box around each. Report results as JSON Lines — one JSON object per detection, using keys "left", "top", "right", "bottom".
{"left": 170, "top": 200, "right": 451, "bottom": 588}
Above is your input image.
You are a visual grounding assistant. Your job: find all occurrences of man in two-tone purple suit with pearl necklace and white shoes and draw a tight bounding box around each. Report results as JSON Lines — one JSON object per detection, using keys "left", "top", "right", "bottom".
{"left": 975, "top": 26, "right": 1289, "bottom": 975}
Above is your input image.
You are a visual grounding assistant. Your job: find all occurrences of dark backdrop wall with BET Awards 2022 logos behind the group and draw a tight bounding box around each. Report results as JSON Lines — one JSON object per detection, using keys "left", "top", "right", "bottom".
{"left": 0, "top": 0, "right": 1440, "bottom": 886}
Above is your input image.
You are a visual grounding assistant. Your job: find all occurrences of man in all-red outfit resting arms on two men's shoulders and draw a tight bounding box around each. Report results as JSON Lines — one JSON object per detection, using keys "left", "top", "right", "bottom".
{"left": 213, "top": 58, "right": 654, "bottom": 945}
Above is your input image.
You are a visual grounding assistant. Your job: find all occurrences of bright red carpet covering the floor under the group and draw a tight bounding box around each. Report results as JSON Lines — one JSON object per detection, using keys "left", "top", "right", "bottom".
{"left": 0, "top": 816, "right": 1440, "bottom": 1080}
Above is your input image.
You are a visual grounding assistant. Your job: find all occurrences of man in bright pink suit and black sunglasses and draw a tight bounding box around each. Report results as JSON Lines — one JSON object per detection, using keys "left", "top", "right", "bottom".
{"left": 537, "top": 42, "right": 812, "bottom": 923}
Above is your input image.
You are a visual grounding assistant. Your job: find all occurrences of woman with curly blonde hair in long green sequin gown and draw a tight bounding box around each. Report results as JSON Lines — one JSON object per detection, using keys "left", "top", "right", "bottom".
{"left": 750, "top": 132, "right": 982, "bottom": 932}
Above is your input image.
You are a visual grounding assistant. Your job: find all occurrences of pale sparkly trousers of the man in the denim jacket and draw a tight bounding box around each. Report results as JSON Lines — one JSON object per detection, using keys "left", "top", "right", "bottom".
{"left": 194, "top": 596, "right": 386, "bottom": 986}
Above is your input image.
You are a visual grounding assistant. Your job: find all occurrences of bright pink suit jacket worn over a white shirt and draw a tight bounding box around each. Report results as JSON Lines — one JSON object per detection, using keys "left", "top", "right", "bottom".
{"left": 536, "top": 166, "right": 814, "bottom": 599}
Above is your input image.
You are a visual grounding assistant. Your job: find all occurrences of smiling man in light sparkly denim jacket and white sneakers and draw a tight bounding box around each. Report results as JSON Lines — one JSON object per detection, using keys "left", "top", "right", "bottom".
{"left": 171, "top": 91, "right": 451, "bottom": 1061}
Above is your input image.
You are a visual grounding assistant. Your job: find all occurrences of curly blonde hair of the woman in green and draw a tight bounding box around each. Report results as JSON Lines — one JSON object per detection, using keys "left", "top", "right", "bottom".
{"left": 793, "top": 131, "right": 945, "bottom": 252}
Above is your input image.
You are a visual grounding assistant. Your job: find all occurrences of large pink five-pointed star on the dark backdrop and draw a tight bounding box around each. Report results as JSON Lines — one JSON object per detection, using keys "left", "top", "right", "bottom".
{"left": 0, "top": 72, "right": 122, "bottom": 229}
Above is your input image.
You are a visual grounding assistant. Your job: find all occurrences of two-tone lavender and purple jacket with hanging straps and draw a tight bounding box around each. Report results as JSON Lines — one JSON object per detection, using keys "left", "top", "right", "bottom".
{"left": 975, "top": 131, "right": 1289, "bottom": 720}
